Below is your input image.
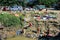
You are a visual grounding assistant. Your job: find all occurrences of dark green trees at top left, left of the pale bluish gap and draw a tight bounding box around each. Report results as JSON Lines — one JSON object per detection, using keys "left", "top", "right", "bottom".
{"left": 0, "top": 0, "right": 25, "bottom": 6}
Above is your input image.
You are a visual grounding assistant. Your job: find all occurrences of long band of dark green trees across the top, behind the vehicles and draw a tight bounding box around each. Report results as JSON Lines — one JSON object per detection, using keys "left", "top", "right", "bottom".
{"left": 0, "top": 0, "right": 59, "bottom": 7}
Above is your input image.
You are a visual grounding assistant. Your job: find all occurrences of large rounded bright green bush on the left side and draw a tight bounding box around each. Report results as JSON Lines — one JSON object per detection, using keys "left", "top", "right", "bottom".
{"left": 0, "top": 13, "right": 20, "bottom": 27}
